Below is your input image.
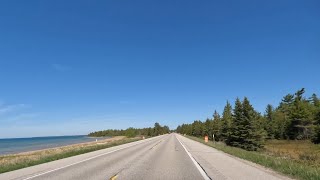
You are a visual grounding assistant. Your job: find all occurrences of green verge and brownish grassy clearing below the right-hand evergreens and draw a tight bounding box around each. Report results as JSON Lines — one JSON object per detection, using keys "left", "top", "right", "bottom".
{"left": 187, "top": 136, "right": 320, "bottom": 180}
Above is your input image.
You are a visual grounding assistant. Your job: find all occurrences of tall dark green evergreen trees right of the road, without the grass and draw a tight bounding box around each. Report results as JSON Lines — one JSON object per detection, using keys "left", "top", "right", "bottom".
{"left": 176, "top": 88, "right": 320, "bottom": 151}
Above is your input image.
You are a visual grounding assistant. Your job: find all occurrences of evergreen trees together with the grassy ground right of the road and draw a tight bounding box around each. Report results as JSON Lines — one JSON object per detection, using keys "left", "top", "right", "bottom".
{"left": 176, "top": 88, "right": 320, "bottom": 179}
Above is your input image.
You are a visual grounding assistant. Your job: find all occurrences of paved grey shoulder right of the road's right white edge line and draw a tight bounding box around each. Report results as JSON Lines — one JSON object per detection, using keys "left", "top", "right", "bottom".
{"left": 177, "top": 135, "right": 290, "bottom": 180}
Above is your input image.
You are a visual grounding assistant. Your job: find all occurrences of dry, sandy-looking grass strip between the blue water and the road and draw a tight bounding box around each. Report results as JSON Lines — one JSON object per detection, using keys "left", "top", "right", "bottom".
{"left": 0, "top": 137, "right": 141, "bottom": 174}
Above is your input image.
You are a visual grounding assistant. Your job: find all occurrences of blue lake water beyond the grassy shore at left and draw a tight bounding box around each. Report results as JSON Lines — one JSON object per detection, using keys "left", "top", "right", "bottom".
{"left": 0, "top": 136, "right": 107, "bottom": 155}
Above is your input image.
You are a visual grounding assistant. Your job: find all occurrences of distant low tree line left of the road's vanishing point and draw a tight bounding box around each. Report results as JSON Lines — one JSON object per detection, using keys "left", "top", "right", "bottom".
{"left": 88, "top": 122, "right": 170, "bottom": 137}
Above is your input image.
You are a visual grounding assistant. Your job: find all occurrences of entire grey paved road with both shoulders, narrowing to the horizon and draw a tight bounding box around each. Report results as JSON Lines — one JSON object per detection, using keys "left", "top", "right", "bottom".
{"left": 0, "top": 134, "right": 288, "bottom": 180}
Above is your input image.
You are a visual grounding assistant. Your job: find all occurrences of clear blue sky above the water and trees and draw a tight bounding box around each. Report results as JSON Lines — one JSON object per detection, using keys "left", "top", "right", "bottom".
{"left": 0, "top": 0, "right": 320, "bottom": 138}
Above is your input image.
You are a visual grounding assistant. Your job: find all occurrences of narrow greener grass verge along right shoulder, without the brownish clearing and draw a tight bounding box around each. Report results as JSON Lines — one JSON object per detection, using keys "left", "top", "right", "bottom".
{"left": 188, "top": 136, "right": 320, "bottom": 180}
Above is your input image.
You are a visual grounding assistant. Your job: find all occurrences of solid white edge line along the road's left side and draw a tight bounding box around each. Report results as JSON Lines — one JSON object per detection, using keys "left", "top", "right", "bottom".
{"left": 23, "top": 137, "right": 165, "bottom": 180}
